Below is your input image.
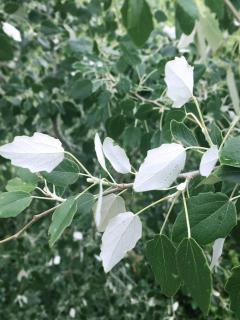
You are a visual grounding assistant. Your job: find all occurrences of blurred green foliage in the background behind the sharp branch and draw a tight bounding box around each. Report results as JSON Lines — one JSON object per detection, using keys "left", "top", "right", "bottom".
{"left": 0, "top": 0, "right": 240, "bottom": 320}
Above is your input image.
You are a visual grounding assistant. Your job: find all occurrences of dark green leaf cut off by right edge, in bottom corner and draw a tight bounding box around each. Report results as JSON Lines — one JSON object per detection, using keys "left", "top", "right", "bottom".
{"left": 225, "top": 266, "right": 240, "bottom": 318}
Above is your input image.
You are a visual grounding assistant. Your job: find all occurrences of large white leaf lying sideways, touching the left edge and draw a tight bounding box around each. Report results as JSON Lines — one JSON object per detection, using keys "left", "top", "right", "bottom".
{"left": 0, "top": 132, "right": 64, "bottom": 172}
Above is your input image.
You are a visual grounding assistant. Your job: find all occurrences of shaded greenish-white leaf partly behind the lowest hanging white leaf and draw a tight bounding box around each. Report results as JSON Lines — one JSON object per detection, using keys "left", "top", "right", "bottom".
{"left": 95, "top": 193, "right": 126, "bottom": 232}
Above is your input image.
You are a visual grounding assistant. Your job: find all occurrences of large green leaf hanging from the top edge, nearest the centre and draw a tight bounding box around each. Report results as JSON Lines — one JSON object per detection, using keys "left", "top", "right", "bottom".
{"left": 121, "top": 0, "right": 153, "bottom": 47}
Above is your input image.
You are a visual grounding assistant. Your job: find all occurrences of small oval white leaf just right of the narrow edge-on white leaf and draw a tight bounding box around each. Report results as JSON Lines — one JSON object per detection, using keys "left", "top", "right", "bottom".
{"left": 103, "top": 137, "right": 131, "bottom": 174}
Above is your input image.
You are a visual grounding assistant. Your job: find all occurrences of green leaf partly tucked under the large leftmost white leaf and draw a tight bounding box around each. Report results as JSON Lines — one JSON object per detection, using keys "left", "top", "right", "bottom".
{"left": 42, "top": 159, "right": 79, "bottom": 187}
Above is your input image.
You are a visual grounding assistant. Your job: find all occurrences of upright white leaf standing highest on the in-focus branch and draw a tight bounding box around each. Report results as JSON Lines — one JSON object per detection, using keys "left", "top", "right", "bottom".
{"left": 164, "top": 57, "right": 193, "bottom": 108}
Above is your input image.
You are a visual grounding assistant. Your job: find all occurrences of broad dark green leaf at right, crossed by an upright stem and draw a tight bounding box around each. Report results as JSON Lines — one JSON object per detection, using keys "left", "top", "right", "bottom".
{"left": 173, "top": 192, "right": 237, "bottom": 244}
